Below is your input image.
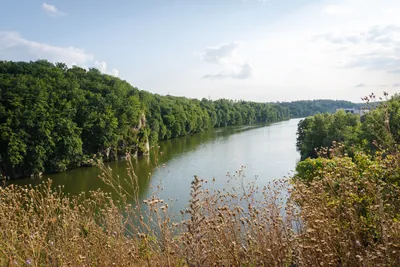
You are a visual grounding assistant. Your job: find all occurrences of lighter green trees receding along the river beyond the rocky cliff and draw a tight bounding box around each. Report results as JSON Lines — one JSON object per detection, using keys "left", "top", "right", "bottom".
{"left": 139, "top": 94, "right": 290, "bottom": 143}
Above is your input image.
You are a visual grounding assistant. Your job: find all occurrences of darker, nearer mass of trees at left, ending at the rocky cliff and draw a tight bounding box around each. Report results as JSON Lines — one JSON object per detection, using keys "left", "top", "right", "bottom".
{"left": 0, "top": 61, "right": 141, "bottom": 177}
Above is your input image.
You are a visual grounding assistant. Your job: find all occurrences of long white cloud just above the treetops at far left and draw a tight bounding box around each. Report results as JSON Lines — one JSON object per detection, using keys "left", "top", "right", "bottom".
{"left": 0, "top": 31, "right": 94, "bottom": 66}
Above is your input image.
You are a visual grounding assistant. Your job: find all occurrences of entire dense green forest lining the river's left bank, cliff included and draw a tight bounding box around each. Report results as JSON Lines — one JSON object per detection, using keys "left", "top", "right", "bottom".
{"left": 0, "top": 60, "right": 290, "bottom": 177}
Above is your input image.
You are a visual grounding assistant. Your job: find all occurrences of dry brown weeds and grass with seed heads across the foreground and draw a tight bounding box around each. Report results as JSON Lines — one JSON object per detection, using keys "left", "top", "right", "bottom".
{"left": 0, "top": 153, "right": 400, "bottom": 266}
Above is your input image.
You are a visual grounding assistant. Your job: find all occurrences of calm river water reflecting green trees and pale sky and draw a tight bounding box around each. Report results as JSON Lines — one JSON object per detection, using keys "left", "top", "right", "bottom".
{"left": 13, "top": 119, "right": 300, "bottom": 213}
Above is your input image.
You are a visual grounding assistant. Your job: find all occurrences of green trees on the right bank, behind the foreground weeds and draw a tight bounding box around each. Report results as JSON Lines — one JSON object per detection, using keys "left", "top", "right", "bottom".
{"left": 297, "top": 94, "right": 400, "bottom": 159}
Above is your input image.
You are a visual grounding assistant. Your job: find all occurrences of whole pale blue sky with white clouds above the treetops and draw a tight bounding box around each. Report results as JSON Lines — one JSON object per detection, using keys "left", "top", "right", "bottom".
{"left": 0, "top": 0, "right": 400, "bottom": 102}
